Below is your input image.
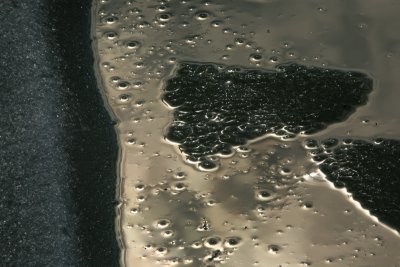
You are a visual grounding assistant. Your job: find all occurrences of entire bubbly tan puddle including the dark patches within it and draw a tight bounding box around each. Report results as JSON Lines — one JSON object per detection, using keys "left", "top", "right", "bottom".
{"left": 92, "top": 0, "right": 400, "bottom": 267}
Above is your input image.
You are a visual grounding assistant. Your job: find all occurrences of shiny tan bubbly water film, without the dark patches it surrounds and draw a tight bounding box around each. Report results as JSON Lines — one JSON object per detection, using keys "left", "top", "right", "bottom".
{"left": 92, "top": 0, "right": 400, "bottom": 267}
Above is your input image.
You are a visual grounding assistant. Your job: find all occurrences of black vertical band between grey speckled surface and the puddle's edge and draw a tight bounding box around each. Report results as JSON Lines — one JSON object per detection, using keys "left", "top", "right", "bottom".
{"left": 49, "top": 0, "right": 118, "bottom": 266}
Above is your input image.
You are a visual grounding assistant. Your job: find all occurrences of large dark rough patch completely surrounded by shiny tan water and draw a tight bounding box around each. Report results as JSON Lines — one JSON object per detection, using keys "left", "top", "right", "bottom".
{"left": 163, "top": 63, "right": 372, "bottom": 169}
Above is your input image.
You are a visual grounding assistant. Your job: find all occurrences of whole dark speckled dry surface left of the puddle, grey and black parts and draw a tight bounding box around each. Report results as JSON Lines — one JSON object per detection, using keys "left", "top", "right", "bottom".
{"left": 0, "top": 0, "right": 119, "bottom": 266}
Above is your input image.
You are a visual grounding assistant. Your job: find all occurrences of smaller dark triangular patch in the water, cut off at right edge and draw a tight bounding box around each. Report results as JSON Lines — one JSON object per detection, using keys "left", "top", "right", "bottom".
{"left": 312, "top": 139, "right": 400, "bottom": 230}
